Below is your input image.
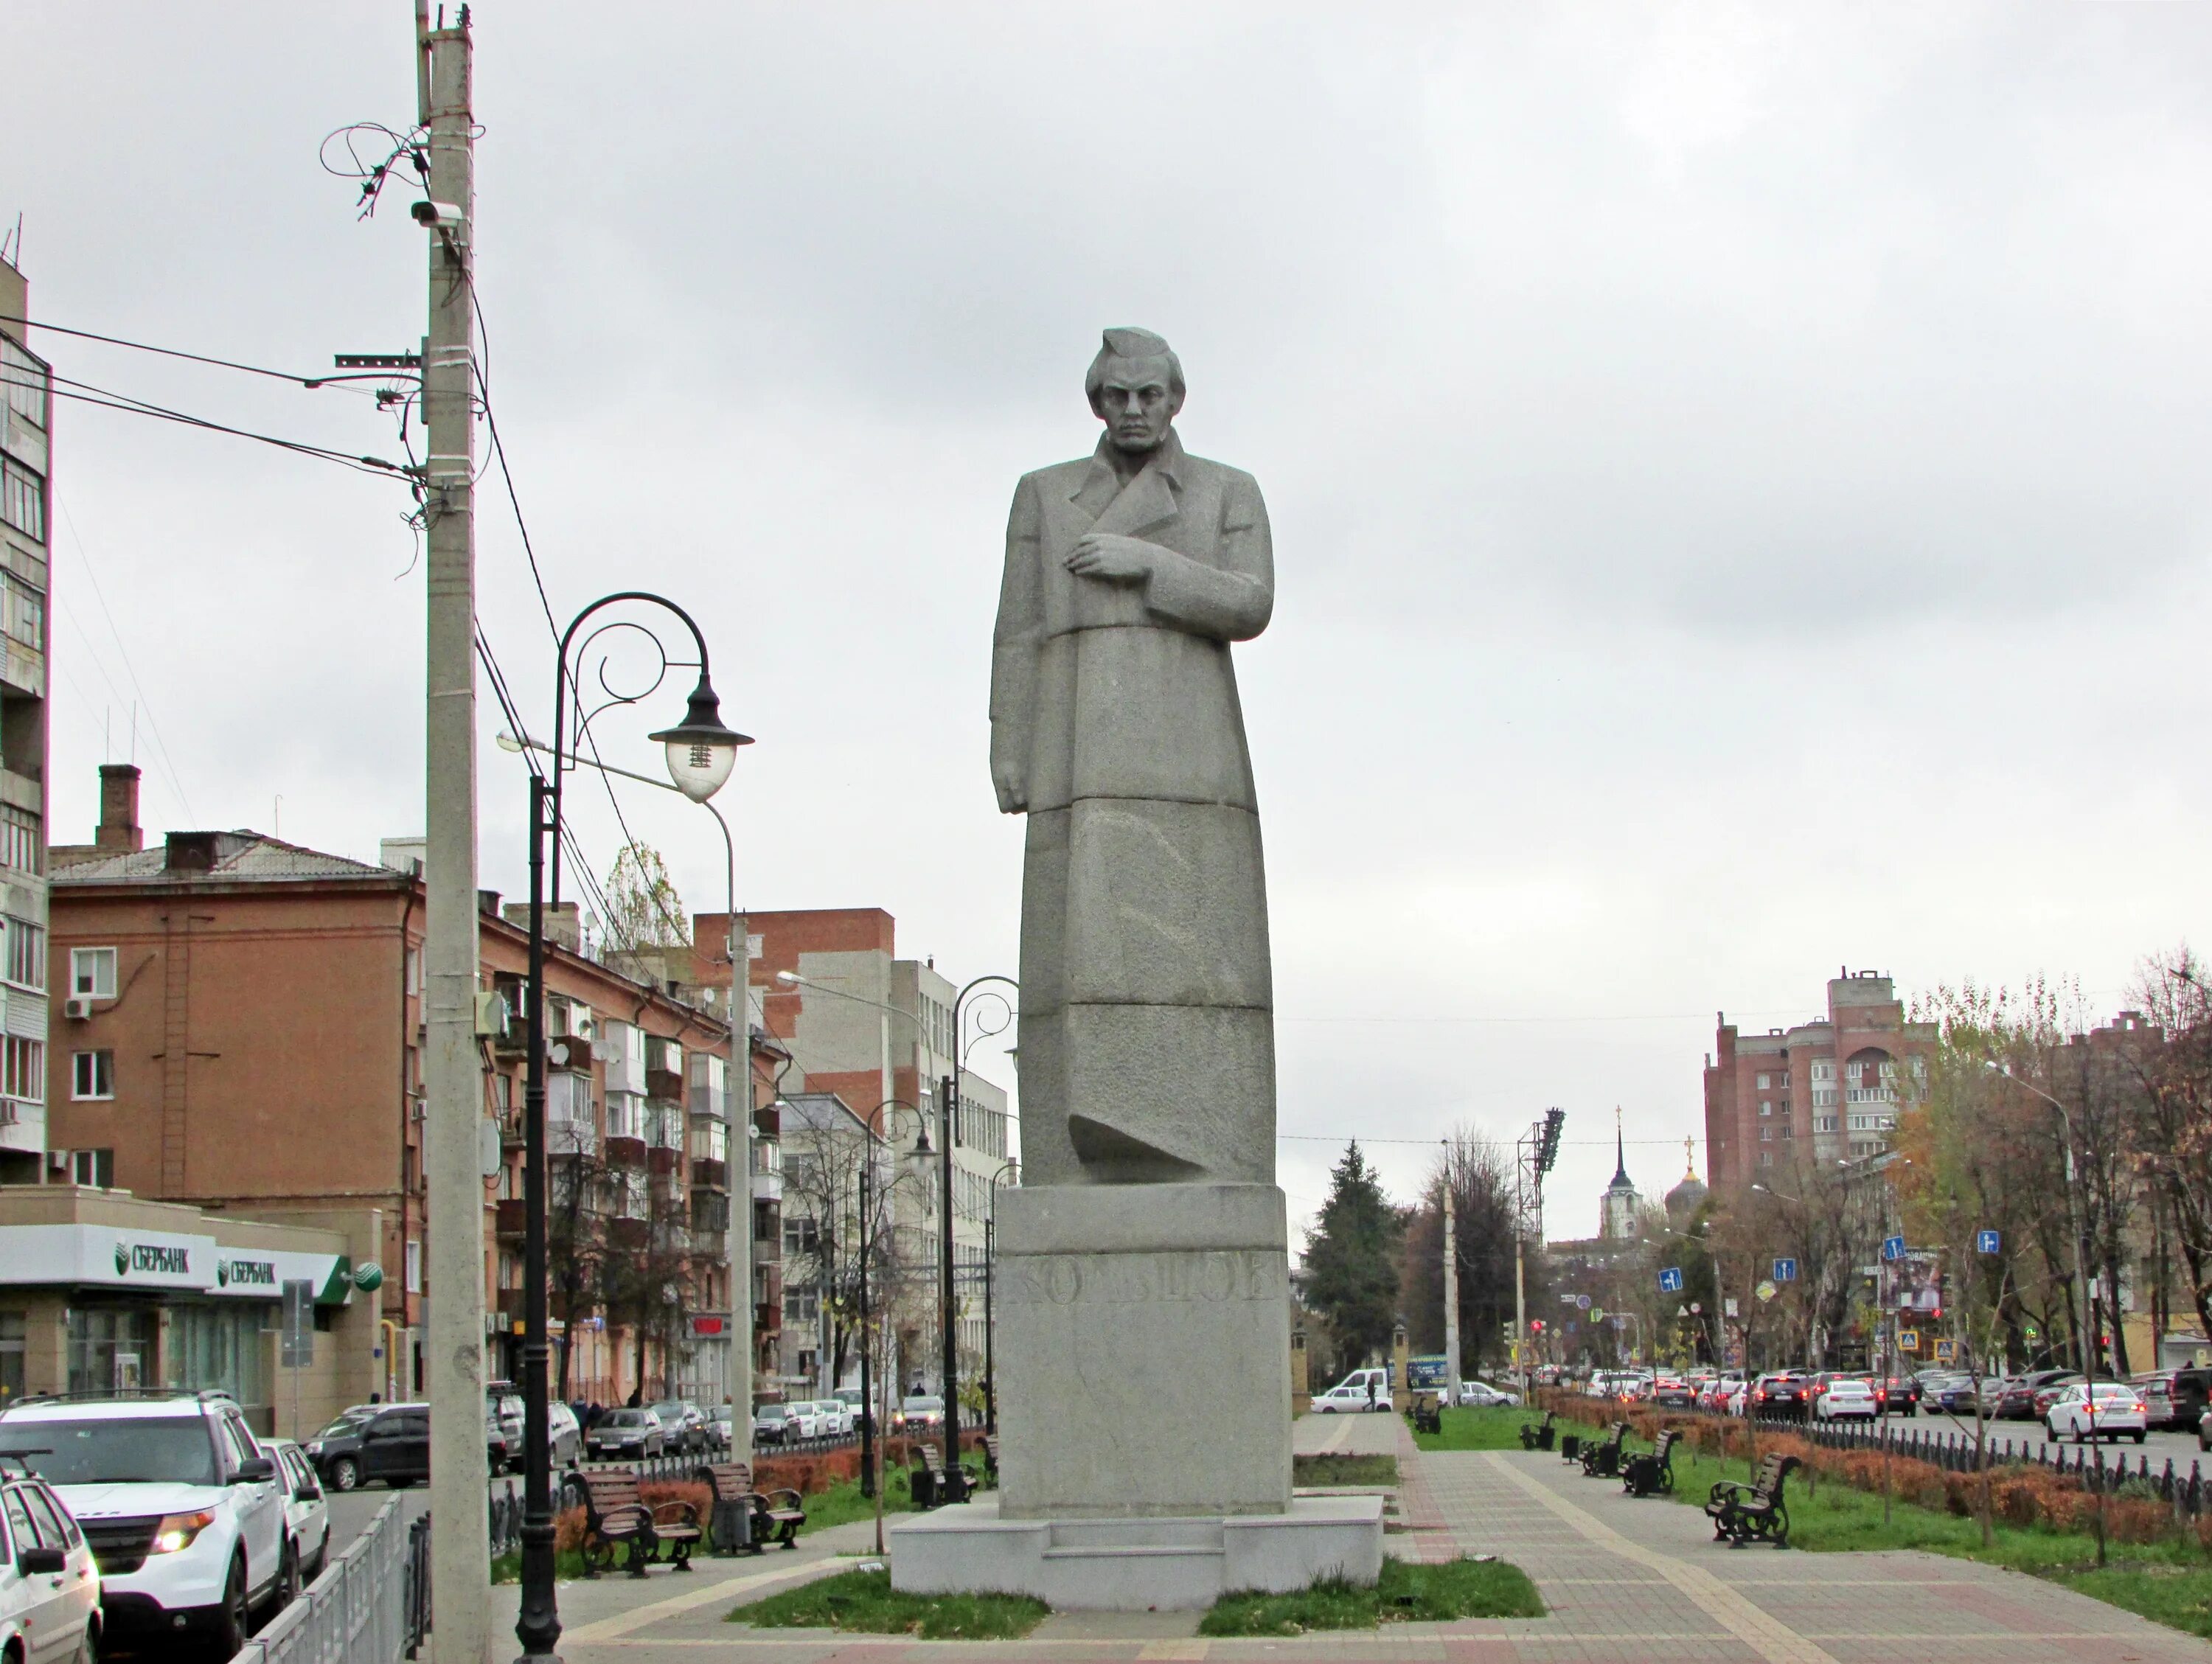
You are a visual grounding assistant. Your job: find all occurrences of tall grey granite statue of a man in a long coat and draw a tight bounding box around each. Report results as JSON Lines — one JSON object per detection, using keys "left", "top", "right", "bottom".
{"left": 991, "top": 330, "right": 1274, "bottom": 1186}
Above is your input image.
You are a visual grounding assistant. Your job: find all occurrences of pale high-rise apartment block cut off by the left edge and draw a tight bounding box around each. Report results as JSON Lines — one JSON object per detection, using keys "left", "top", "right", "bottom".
{"left": 0, "top": 261, "right": 53, "bottom": 1184}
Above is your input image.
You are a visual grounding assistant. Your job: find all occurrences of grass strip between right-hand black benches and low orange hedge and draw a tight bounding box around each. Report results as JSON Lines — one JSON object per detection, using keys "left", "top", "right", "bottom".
{"left": 1548, "top": 1407, "right": 2212, "bottom": 1635}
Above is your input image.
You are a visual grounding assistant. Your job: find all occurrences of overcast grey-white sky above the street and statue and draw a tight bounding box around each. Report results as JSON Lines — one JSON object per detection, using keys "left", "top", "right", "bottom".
{"left": 0, "top": 0, "right": 2212, "bottom": 1235}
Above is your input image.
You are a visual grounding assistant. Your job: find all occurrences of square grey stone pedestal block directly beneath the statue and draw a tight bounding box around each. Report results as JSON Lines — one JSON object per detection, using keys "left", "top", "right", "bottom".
{"left": 998, "top": 1184, "right": 1290, "bottom": 1520}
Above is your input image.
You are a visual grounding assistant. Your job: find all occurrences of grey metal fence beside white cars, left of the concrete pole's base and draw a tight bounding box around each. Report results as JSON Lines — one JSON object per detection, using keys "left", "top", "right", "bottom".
{"left": 232, "top": 1498, "right": 429, "bottom": 1664}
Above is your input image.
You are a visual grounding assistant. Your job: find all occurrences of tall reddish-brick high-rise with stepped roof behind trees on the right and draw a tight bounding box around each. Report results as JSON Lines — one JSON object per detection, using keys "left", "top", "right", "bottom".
{"left": 1705, "top": 967, "right": 1935, "bottom": 1195}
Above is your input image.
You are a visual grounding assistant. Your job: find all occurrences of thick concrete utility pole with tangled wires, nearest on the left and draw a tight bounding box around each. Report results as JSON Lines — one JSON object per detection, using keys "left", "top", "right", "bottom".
{"left": 414, "top": 7, "right": 491, "bottom": 1664}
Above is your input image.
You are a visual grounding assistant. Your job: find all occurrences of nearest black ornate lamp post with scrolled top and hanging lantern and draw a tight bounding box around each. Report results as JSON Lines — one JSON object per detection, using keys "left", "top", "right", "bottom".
{"left": 515, "top": 591, "right": 752, "bottom": 1657}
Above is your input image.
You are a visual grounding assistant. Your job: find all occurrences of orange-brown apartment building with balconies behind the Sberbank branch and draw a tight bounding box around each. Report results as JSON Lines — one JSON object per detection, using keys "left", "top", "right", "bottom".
{"left": 46, "top": 770, "right": 743, "bottom": 1403}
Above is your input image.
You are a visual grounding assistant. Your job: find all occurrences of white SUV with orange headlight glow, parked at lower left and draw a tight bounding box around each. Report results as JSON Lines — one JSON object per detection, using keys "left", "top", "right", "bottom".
{"left": 0, "top": 1392, "right": 299, "bottom": 1660}
